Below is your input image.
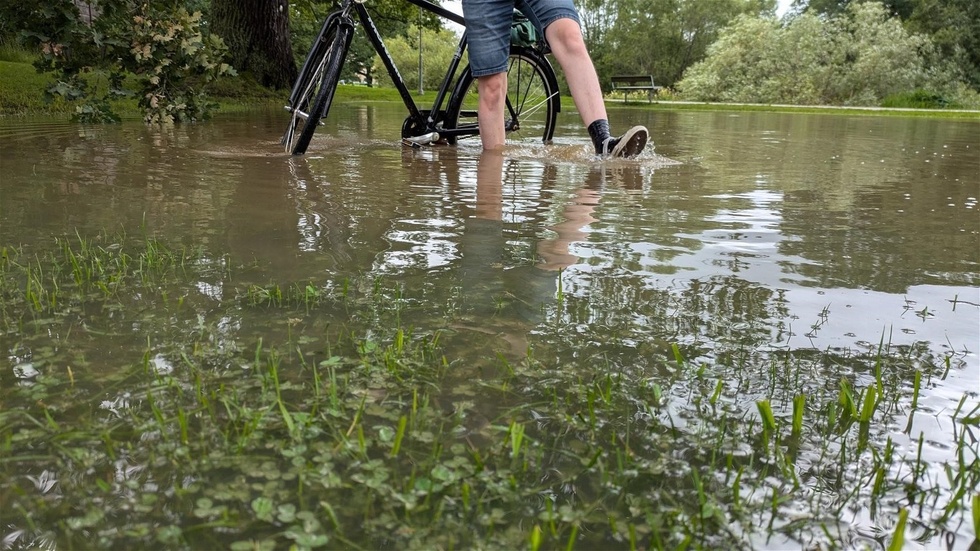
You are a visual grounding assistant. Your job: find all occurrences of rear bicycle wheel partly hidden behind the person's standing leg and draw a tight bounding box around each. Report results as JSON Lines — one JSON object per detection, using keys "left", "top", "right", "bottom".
{"left": 443, "top": 45, "right": 561, "bottom": 144}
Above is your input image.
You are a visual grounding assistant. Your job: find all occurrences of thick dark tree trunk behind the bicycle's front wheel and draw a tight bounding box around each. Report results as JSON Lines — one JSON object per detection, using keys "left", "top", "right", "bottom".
{"left": 211, "top": 0, "right": 297, "bottom": 89}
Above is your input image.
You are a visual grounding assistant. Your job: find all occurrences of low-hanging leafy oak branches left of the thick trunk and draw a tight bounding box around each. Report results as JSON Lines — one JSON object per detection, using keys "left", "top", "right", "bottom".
{"left": 30, "top": 0, "right": 234, "bottom": 123}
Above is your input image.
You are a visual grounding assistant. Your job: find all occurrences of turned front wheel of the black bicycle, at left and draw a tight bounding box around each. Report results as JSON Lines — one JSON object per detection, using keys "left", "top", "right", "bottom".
{"left": 282, "top": 19, "right": 353, "bottom": 155}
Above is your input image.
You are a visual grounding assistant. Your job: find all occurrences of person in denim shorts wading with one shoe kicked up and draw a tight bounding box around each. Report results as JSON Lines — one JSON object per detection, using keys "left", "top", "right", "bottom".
{"left": 463, "top": 0, "right": 649, "bottom": 157}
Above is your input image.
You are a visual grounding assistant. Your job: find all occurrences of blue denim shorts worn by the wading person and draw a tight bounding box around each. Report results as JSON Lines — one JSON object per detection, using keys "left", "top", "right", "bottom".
{"left": 463, "top": 0, "right": 582, "bottom": 77}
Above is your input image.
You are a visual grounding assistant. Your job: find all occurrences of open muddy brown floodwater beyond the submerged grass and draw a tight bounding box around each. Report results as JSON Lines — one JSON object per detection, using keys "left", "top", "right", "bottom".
{"left": 0, "top": 104, "right": 980, "bottom": 548}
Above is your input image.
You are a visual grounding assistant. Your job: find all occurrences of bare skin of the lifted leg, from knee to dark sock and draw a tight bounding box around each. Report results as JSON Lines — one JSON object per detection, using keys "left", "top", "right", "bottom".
{"left": 545, "top": 18, "right": 607, "bottom": 126}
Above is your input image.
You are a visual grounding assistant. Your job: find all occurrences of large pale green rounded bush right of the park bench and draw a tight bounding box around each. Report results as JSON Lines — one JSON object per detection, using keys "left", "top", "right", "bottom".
{"left": 678, "top": 2, "right": 958, "bottom": 105}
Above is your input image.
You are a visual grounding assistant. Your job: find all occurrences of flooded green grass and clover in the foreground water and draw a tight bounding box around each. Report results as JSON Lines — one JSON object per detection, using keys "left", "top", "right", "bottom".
{"left": 0, "top": 234, "right": 980, "bottom": 550}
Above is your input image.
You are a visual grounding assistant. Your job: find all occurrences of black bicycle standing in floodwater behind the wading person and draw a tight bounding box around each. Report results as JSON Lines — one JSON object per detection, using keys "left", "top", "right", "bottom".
{"left": 282, "top": 0, "right": 561, "bottom": 155}
